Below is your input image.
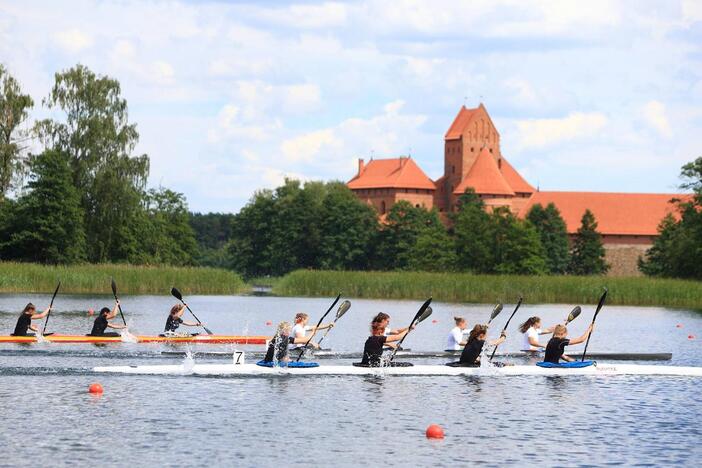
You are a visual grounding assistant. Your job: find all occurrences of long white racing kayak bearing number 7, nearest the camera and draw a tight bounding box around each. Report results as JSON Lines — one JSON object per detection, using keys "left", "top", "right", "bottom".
{"left": 93, "top": 362, "right": 702, "bottom": 377}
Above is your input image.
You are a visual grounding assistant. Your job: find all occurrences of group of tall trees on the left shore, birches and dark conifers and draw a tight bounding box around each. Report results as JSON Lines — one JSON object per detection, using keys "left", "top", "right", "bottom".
{"left": 0, "top": 65, "right": 198, "bottom": 265}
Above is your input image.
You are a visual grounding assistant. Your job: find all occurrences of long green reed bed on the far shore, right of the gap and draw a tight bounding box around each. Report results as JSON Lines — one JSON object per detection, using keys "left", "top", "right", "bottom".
{"left": 273, "top": 270, "right": 702, "bottom": 309}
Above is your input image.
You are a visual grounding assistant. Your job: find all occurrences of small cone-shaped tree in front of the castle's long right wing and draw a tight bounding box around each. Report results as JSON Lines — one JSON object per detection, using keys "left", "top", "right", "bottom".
{"left": 568, "top": 210, "right": 609, "bottom": 275}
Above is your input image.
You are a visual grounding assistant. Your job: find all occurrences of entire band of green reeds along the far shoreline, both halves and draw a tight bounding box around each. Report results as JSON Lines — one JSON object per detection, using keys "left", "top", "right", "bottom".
{"left": 0, "top": 262, "right": 702, "bottom": 309}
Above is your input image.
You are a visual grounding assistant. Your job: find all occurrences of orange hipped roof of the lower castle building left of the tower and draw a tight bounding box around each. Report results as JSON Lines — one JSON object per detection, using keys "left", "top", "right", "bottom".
{"left": 347, "top": 157, "right": 436, "bottom": 190}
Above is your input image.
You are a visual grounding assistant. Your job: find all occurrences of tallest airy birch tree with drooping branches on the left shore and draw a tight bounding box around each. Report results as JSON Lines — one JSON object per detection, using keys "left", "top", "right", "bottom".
{"left": 36, "top": 65, "right": 149, "bottom": 262}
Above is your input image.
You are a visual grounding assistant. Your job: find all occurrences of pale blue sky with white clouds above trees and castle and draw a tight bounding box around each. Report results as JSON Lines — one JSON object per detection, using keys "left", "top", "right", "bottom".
{"left": 0, "top": 0, "right": 702, "bottom": 212}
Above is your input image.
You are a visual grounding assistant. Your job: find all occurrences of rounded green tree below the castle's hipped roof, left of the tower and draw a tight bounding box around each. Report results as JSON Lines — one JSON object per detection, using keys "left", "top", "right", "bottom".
{"left": 375, "top": 200, "right": 444, "bottom": 270}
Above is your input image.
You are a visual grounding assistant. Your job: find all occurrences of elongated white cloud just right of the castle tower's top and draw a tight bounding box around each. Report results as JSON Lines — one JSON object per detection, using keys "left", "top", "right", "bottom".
{"left": 517, "top": 112, "right": 608, "bottom": 148}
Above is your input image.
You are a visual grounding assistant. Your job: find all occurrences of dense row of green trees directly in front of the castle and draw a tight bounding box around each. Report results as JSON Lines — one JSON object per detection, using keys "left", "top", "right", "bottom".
{"left": 191, "top": 180, "right": 608, "bottom": 278}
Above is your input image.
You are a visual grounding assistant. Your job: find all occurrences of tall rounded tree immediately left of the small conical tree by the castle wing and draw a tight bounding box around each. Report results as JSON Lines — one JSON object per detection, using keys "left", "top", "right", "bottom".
{"left": 526, "top": 203, "right": 570, "bottom": 275}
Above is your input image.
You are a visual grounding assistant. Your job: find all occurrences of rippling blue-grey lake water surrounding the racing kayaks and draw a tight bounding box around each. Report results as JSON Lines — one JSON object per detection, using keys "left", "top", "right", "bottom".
{"left": 0, "top": 295, "right": 702, "bottom": 466}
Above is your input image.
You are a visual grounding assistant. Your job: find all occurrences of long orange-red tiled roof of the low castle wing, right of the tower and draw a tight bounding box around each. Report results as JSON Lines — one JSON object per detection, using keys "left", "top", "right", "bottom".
{"left": 519, "top": 192, "right": 687, "bottom": 236}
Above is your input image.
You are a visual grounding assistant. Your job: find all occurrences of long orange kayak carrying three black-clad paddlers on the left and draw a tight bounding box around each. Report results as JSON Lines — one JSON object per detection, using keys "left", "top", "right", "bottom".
{"left": 0, "top": 335, "right": 270, "bottom": 344}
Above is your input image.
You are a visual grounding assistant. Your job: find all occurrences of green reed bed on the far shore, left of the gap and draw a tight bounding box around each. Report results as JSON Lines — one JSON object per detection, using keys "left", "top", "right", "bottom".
{"left": 0, "top": 262, "right": 246, "bottom": 295}
